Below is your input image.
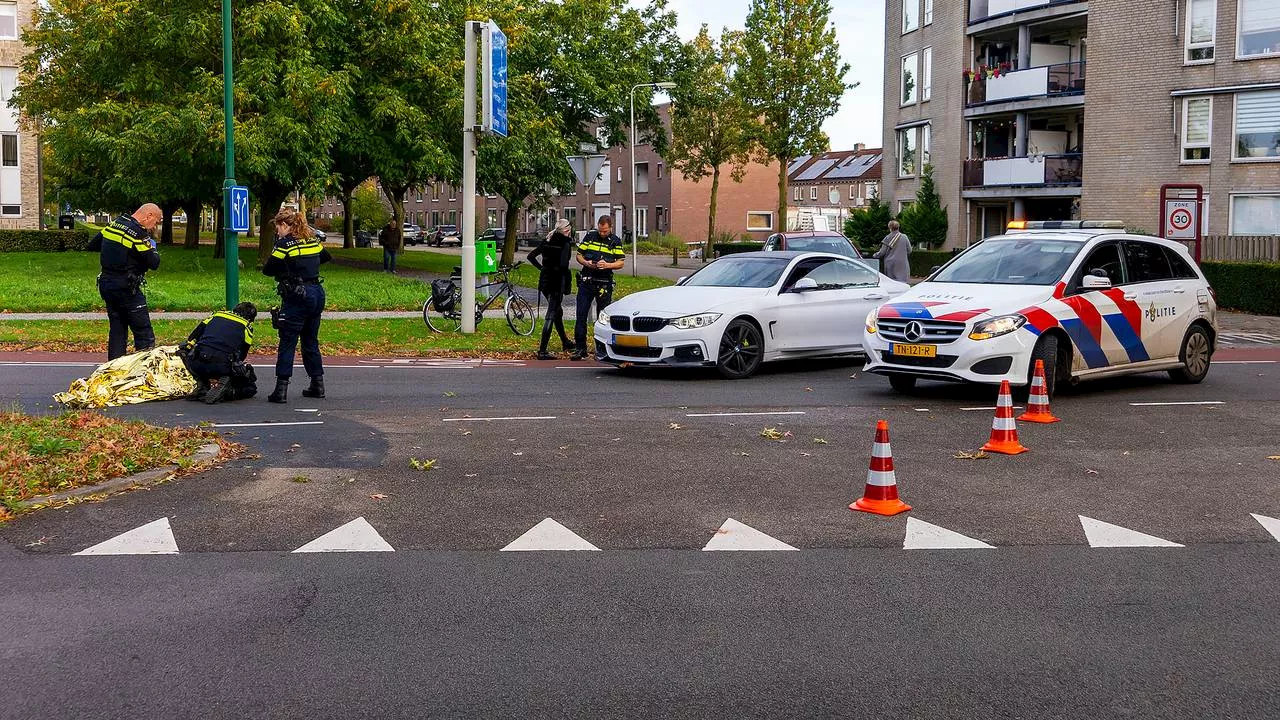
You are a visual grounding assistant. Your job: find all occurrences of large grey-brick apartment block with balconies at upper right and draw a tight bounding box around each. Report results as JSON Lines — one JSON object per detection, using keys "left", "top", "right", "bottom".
{"left": 884, "top": 0, "right": 1280, "bottom": 246}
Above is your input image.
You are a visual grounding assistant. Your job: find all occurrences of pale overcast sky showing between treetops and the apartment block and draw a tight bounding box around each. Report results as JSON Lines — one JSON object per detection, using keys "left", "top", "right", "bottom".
{"left": 631, "top": 0, "right": 884, "bottom": 150}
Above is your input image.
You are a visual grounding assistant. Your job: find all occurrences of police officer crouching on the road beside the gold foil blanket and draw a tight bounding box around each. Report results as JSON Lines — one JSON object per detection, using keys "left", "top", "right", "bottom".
{"left": 179, "top": 302, "right": 257, "bottom": 405}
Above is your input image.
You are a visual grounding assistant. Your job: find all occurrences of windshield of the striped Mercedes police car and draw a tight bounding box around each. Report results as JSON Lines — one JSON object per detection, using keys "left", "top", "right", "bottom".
{"left": 931, "top": 237, "right": 1084, "bottom": 284}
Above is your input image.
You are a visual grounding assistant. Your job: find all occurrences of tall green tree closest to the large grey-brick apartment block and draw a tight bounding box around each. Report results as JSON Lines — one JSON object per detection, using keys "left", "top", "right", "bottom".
{"left": 733, "top": 0, "right": 855, "bottom": 227}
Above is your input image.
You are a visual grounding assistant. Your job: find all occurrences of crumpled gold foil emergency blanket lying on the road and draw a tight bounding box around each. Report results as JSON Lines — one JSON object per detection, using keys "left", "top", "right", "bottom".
{"left": 54, "top": 345, "right": 196, "bottom": 409}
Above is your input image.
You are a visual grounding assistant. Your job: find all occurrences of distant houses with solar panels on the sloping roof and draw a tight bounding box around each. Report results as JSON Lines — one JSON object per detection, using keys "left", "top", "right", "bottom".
{"left": 787, "top": 142, "right": 883, "bottom": 231}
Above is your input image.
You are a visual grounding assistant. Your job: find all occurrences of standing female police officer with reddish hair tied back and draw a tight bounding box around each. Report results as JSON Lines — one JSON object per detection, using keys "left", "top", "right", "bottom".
{"left": 262, "top": 208, "right": 332, "bottom": 402}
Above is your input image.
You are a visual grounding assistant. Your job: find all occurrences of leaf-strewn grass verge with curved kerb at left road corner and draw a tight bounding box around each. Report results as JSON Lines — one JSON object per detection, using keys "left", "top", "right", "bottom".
{"left": 0, "top": 413, "right": 218, "bottom": 523}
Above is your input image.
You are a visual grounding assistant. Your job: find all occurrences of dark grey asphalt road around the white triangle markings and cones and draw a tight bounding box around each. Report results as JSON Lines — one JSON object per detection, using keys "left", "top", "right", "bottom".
{"left": 0, "top": 351, "right": 1280, "bottom": 719}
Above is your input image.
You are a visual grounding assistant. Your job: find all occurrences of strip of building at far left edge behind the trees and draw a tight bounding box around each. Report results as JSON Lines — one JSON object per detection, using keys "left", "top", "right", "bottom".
{"left": 0, "top": 0, "right": 40, "bottom": 229}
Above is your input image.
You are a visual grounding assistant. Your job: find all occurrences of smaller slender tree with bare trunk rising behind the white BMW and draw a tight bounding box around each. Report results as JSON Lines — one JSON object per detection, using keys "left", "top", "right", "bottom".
{"left": 668, "top": 26, "right": 756, "bottom": 263}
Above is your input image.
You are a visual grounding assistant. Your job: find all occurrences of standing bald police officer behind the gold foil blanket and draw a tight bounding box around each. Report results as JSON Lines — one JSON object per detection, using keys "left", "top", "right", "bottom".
{"left": 88, "top": 202, "right": 164, "bottom": 360}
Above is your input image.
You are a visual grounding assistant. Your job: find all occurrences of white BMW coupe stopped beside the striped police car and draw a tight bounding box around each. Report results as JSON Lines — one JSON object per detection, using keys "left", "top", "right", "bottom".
{"left": 594, "top": 252, "right": 909, "bottom": 379}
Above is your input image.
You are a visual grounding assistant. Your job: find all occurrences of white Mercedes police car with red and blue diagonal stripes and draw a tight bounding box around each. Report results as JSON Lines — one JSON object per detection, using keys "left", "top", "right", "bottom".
{"left": 863, "top": 220, "right": 1217, "bottom": 395}
